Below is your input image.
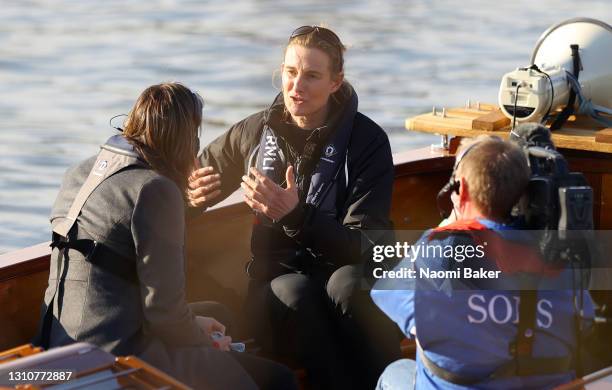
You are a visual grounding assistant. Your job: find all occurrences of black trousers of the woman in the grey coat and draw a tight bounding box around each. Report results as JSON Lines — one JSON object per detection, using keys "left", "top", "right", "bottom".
{"left": 189, "top": 301, "right": 297, "bottom": 390}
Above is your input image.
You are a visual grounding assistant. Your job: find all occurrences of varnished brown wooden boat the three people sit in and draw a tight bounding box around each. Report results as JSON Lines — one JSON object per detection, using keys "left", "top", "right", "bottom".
{"left": 0, "top": 104, "right": 612, "bottom": 386}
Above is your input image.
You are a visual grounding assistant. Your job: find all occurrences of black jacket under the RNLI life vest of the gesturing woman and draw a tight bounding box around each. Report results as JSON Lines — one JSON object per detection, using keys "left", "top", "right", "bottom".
{"left": 200, "top": 87, "right": 394, "bottom": 276}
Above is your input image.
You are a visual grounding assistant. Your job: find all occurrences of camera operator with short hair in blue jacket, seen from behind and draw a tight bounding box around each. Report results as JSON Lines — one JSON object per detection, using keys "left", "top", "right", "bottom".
{"left": 371, "top": 137, "right": 592, "bottom": 389}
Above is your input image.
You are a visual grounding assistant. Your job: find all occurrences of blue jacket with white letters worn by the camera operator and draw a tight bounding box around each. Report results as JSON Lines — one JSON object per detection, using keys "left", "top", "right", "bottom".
{"left": 371, "top": 220, "right": 593, "bottom": 389}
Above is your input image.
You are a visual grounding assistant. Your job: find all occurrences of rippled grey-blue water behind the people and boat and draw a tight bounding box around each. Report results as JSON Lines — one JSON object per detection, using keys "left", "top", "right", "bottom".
{"left": 0, "top": 0, "right": 612, "bottom": 253}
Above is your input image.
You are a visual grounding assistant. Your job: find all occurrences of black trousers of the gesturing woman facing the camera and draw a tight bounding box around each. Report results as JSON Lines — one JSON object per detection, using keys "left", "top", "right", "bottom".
{"left": 246, "top": 265, "right": 400, "bottom": 389}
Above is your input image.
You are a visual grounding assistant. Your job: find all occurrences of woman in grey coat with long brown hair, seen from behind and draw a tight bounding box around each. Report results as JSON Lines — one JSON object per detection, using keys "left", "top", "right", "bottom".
{"left": 40, "top": 83, "right": 295, "bottom": 389}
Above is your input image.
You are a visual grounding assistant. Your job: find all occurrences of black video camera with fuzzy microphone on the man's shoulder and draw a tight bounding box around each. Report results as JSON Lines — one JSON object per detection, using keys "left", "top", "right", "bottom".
{"left": 510, "top": 123, "right": 593, "bottom": 268}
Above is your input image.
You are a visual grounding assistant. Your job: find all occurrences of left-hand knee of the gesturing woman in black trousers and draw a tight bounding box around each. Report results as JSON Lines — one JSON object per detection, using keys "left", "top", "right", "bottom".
{"left": 270, "top": 274, "right": 320, "bottom": 310}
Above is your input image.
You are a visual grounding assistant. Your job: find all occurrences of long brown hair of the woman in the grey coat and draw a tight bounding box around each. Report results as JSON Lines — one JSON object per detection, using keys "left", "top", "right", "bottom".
{"left": 123, "top": 83, "right": 203, "bottom": 192}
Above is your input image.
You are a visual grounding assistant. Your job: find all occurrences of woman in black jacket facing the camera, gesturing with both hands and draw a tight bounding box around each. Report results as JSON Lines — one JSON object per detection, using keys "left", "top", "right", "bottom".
{"left": 190, "top": 26, "right": 399, "bottom": 388}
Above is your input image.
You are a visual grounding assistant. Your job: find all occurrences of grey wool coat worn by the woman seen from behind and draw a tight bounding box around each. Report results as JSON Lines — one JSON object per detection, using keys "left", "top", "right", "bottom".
{"left": 37, "top": 140, "right": 255, "bottom": 388}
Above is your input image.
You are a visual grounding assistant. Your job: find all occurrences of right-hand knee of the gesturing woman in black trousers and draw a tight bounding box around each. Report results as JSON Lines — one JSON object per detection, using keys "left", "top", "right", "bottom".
{"left": 326, "top": 265, "right": 367, "bottom": 314}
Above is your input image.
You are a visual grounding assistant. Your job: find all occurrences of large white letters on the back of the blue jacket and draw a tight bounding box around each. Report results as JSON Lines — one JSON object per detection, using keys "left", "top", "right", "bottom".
{"left": 467, "top": 294, "right": 553, "bottom": 329}
